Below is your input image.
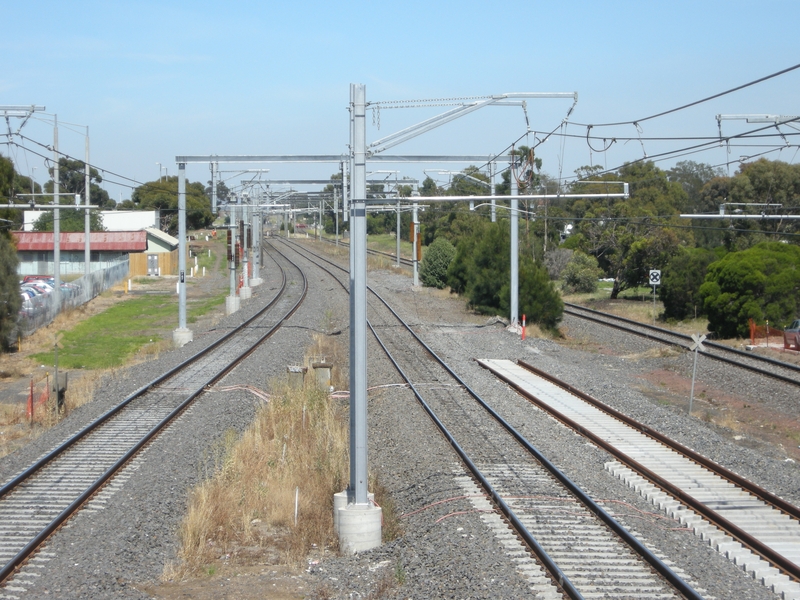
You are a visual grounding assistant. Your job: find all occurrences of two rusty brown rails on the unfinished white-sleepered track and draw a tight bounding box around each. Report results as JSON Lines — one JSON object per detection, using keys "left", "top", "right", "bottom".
{"left": 496, "top": 361, "right": 800, "bottom": 580}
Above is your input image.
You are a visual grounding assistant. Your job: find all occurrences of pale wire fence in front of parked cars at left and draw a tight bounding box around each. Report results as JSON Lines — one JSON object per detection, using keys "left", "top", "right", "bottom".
{"left": 19, "top": 255, "right": 128, "bottom": 335}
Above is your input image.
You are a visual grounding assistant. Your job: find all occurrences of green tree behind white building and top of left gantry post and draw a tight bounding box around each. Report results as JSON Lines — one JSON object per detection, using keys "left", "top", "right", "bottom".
{"left": 130, "top": 177, "right": 214, "bottom": 235}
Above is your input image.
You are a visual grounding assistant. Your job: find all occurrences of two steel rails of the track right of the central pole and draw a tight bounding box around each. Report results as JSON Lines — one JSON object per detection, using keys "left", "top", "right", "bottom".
{"left": 278, "top": 238, "right": 703, "bottom": 600}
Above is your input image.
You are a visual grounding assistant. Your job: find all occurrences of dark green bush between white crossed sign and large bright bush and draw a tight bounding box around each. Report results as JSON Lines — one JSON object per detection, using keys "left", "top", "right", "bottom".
{"left": 658, "top": 248, "right": 720, "bottom": 320}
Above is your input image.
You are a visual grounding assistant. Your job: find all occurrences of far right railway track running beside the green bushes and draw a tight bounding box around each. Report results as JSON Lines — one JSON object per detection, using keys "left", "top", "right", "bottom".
{"left": 564, "top": 302, "right": 800, "bottom": 387}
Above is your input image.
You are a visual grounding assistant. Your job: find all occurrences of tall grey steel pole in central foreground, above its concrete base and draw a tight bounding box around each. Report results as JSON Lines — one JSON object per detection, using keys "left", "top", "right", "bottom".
{"left": 348, "top": 84, "right": 369, "bottom": 505}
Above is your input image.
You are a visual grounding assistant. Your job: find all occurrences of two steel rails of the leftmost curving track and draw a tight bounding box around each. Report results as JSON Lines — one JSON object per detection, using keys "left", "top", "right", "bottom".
{"left": 0, "top": 243, "right": 308, "bottom": 582}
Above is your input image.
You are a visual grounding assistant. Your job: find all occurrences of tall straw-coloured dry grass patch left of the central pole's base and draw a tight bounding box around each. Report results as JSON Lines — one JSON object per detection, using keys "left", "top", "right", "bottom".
{"left": 164, "top": 336, "right": 349, "bottom": 579}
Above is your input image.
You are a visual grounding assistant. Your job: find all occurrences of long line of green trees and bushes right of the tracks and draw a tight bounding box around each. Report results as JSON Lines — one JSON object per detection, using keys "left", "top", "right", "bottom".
{"left": 412, "top": 156, "right": 800, "bottom": 337}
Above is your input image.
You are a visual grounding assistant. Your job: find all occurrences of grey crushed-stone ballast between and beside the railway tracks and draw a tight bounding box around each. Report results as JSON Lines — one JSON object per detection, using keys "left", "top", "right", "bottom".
{"left": 0, "top": 240, "right": 800, "bottom": 599}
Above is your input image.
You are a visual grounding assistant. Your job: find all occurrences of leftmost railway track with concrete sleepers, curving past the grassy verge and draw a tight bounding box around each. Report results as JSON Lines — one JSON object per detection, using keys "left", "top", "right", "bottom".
{"left": 0, "top": 243, "right": 307, "bottom": 583}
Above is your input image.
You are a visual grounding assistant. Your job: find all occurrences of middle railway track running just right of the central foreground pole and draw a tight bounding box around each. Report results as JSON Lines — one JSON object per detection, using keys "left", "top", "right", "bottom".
{"left": 278, "top": 239, "right": 701, "bottom": 598}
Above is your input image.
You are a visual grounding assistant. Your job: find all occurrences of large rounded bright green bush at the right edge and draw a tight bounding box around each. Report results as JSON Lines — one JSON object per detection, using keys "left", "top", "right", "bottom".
{"left": 700, "top": 242, "right": 800, "bottom": 337}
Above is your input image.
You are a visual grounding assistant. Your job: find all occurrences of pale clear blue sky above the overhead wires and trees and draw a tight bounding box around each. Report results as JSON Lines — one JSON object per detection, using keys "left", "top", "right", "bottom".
{"left": 0, "top": 0, "right": 800, "bottom": 200}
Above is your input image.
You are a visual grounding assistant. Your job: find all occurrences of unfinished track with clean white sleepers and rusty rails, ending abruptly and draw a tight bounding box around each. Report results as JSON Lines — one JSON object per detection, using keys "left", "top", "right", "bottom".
{"left": 479, "top": 360, "right": 800, "bottom": 598}
